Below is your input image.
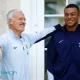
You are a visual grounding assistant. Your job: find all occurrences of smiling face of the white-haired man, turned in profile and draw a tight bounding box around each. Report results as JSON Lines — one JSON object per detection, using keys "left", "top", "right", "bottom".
{"left": 8, "top": 11, "right": 26, "bottom": 33}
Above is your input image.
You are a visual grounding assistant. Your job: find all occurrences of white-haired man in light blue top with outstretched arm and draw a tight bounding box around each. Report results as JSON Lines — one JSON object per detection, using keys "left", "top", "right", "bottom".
{"left": 0, "top": 10, "right": 59, "bottom": 80}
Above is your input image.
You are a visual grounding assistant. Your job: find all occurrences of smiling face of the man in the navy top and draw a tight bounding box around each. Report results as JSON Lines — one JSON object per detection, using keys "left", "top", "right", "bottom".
{"left": 64, "top": 8, "right": 79, "bottom": 27}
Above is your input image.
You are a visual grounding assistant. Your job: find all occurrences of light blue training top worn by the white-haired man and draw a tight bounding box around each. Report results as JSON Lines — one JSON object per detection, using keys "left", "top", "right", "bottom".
{"left": 0, "top": 24, "right": 60, "bottom": 80}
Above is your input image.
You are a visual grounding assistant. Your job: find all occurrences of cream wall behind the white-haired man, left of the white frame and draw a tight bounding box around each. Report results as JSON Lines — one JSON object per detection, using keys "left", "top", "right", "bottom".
{"left": 0, "top": 0, "right": 20, "bottom": 57}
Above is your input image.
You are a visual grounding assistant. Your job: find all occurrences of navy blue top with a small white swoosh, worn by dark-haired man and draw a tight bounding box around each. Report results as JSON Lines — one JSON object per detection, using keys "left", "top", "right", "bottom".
{"left": 47, "top": 25, "right": 80, "bottom": 80}
